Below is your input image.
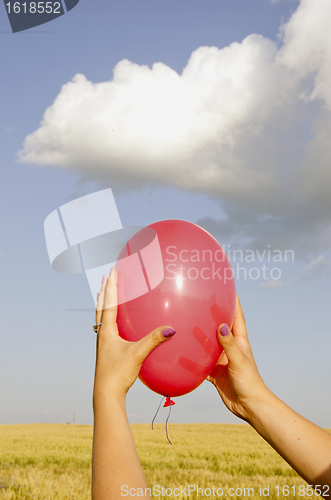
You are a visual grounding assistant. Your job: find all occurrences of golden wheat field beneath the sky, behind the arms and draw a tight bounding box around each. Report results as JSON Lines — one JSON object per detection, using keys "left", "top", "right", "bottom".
{"left": 0, "top": 424, "right": 326, "bottom": 500}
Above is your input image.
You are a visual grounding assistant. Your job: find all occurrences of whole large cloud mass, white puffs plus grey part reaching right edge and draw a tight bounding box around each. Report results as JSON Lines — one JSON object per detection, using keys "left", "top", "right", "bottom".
{"left": 18, "top": 0, "right": 331, "bottom": 253}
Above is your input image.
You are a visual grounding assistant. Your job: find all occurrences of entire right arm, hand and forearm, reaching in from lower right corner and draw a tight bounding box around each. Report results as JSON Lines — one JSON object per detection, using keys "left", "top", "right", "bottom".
{"left": 209, "top": 297, "right": 331, "bottom": 498}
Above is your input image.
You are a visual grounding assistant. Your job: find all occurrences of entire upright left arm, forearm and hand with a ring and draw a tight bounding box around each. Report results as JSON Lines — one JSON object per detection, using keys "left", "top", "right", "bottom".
{"left": 92, "top": 269, "right": 175, "bottom": 500}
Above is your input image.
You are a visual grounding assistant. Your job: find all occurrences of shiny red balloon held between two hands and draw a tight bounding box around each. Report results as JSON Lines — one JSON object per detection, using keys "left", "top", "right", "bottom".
{"left": 115, "top": 220, "right": 236, "bottom": 397}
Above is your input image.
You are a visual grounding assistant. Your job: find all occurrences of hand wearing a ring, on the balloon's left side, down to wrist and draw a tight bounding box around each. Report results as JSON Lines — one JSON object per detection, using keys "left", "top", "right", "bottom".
{"left": 94, "top": 268, "right": 175, "bottom": 402}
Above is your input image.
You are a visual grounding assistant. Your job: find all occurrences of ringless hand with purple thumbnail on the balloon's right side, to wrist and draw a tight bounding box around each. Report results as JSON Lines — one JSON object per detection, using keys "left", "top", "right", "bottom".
{"left": 207, "top": 295, "right": 270, "bottom": 421}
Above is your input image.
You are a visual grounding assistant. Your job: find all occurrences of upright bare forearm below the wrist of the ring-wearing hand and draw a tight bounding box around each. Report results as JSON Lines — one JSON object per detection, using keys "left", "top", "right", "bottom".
{"left": 92, "top": 389, "right": 150, "bottom": 500}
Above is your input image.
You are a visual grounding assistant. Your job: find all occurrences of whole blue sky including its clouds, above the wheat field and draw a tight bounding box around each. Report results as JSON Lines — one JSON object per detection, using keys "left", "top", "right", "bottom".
{"left": 0, "top": 0, "right": 331, "bottom": 427}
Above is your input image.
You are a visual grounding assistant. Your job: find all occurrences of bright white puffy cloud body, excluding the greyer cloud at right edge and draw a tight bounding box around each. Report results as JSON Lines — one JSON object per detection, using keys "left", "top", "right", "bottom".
{"left": 19, "top": 35, "right": 281, "bottom": 199}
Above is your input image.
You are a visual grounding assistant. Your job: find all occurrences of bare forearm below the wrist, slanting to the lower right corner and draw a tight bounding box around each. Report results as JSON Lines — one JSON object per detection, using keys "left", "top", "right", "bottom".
{"left": 248, "top": 390, "right": 331, "bottom": 493}
